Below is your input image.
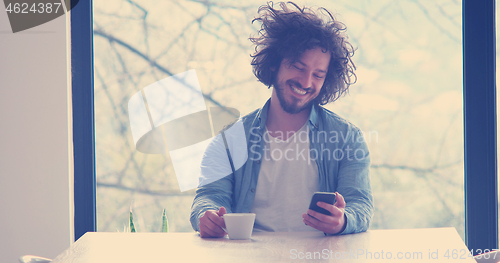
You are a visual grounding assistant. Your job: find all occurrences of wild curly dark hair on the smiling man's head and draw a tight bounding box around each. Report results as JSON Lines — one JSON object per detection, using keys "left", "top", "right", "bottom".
{"left": 250, "top": 2, "right": 356, "bottom": 105}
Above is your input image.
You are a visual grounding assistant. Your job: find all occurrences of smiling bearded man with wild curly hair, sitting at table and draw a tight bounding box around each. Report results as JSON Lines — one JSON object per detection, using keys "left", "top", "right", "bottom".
{"left": 191, "top": 2, "right": 373, "bottom": 237}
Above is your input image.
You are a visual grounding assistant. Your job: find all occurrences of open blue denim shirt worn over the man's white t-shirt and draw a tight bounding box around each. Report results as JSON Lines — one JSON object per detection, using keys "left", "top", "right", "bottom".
{"left": 190, "top": 100, "right": 373, "bottom": 234}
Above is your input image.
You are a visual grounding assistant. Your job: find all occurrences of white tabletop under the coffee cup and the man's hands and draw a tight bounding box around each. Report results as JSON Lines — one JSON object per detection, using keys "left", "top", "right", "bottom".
{"left": 54, "top": 228, "right": 475, "bottom": 263}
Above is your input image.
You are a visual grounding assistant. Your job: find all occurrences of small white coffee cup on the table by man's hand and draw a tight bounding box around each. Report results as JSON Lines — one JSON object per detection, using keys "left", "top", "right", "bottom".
{"left": 222, "top": 213, "right": 255, "bottom": 239}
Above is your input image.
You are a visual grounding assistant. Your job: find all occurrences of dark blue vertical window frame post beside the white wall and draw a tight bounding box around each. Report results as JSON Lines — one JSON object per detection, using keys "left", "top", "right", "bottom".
{"left": 70, "top": 0, "right": 97, "bottom": 241}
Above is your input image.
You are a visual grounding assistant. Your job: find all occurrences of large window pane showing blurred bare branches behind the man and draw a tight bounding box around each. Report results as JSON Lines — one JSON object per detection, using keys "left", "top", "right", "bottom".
{"left": 75, "top": 0, "right": 496, "bottom": 252}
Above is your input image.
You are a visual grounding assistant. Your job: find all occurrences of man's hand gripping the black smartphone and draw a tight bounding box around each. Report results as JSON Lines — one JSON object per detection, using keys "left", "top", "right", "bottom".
{"left": 302, "top": 192, "right": 347, "bottom": 237}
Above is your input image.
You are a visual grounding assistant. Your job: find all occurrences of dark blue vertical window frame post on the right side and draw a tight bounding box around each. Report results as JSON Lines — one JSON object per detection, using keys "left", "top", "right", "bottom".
{"left": 462, "top": 0, "right": 498, "bottom": 254}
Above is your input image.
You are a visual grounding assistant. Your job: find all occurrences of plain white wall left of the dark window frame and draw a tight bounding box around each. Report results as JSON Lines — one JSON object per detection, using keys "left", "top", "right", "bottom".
{"left": 0, "top": 8, "right": 71, "bottom": 263}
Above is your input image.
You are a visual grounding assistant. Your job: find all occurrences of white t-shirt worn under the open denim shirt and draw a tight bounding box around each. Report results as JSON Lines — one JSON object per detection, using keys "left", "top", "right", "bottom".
{"left": 250, "top": 122, "right": 319, "bottom": 232}
